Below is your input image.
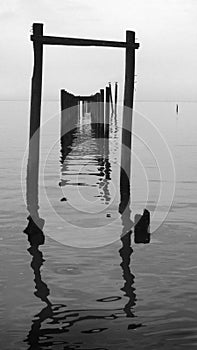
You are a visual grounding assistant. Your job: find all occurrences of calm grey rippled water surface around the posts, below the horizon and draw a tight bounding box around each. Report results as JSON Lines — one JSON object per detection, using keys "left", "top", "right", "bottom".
{"left": 0, "top": 102, "right": 197, "bottom": 350}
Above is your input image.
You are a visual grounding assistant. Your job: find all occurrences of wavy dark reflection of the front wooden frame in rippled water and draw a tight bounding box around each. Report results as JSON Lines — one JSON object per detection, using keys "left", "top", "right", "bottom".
{"left": 24, "top": 232, "right": 141, "bottom": 350}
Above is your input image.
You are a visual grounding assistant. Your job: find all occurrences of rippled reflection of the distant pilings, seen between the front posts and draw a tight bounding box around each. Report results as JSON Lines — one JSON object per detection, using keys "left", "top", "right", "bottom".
{"left": 60, "top": 109, "right": 111, "bottom": 204}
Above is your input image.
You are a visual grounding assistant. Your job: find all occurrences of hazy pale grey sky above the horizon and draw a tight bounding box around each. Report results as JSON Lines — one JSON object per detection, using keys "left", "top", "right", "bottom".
{"left": 0, "top": 0, "right": 197, "bottom": 100}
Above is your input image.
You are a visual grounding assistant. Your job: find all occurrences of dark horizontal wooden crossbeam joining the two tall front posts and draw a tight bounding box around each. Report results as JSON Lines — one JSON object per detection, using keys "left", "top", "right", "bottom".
{"left": 31, "top": 35, "right": 140, "bottom": 49}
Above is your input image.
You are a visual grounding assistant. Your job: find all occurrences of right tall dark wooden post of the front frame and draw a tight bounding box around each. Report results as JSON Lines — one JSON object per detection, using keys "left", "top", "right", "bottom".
{"left": 120, "top": 30, "right": 139, "bottom": 206}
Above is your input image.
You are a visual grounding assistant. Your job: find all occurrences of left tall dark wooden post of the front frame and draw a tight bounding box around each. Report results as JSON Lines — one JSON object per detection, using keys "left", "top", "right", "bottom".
{"left": 27, "top": 23, "right": 43, "bottom": 217}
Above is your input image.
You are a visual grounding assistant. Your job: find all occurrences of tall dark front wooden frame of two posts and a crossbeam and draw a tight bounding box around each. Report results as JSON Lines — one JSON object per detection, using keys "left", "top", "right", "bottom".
{"left": 27, "top": 23, "right": 139, "bottom": 228}
